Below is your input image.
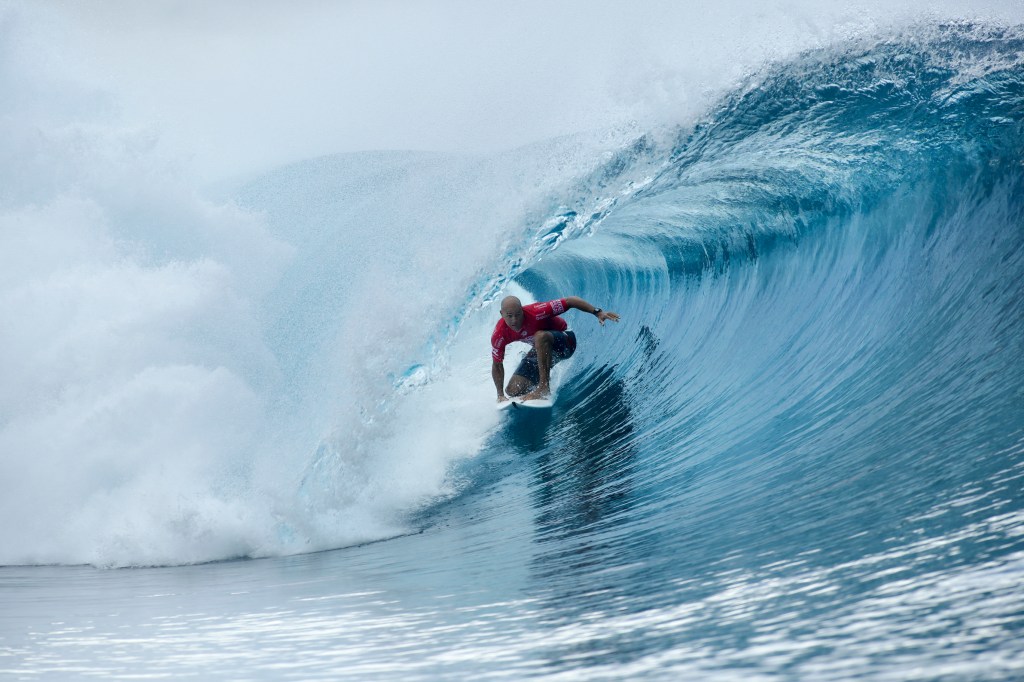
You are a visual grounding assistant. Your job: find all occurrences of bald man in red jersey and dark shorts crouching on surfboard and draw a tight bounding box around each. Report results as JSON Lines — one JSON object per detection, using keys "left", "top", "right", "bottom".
{"left": 490, "top": 296, "right": 618, "bottom": 402}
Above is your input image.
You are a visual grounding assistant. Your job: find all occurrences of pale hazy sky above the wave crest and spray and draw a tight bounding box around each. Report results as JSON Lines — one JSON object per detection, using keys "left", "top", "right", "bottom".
{"left": 48, "top": 0, "right": 1024, "bottom": 178}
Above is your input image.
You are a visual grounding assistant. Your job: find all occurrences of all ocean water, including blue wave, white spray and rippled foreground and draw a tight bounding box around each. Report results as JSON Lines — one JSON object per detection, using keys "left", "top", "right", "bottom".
{"left": 0, "top": 7, "right": 1024, "bottom": 680}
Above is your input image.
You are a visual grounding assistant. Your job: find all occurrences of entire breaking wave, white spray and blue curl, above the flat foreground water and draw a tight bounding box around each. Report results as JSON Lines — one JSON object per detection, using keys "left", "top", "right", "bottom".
{"left": 0, "top": 24, "right": 1024, "bottom": 569}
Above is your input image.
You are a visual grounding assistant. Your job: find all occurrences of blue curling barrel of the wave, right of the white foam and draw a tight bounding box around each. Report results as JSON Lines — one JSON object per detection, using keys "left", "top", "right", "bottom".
{"left": 456, "top": 25, "right": 1024, "bottom": 577}
